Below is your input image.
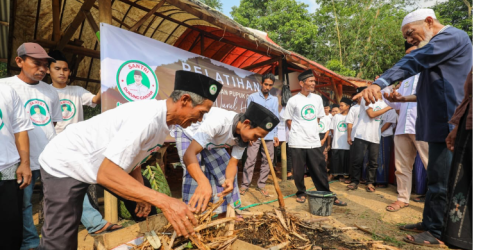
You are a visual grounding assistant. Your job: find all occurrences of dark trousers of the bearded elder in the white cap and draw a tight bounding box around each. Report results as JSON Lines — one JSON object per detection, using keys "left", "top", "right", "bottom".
{"left": 422, "top": 142, "right": 453, "bottom": 239}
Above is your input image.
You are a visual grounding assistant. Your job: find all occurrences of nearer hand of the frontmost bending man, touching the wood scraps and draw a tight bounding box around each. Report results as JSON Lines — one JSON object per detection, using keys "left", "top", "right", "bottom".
{"left": 159, "top": 197, "right": 197, "bottom": 236}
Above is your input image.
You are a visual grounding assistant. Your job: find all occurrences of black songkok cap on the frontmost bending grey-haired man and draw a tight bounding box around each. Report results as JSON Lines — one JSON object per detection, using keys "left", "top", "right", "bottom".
{"left": 174, "top": 70, "right": 222, "bottom": 102}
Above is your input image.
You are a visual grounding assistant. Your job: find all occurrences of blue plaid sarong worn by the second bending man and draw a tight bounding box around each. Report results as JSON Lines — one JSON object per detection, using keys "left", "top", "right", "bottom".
{"left": 174, "top": 126, "right": 241, "bottom": 214}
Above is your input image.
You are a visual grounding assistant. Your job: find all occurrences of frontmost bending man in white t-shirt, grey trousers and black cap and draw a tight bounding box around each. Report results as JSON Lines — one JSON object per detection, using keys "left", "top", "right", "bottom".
{"left": 40, "top": 70, "right": 222, "bottom": 249}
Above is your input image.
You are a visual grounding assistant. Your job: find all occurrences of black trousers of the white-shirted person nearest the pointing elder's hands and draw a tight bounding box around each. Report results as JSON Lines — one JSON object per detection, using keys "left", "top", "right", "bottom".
{"left": 351, "top": 138, "right": 379, "bottom": 184}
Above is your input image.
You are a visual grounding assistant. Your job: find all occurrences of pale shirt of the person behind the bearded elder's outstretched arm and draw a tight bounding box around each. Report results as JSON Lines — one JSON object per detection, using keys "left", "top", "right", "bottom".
{"left": 383, "top": 74, "right": 420, "bottom": 135}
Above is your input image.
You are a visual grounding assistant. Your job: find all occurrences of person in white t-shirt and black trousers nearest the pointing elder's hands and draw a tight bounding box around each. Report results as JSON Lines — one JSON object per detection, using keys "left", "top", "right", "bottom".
{"left": 347, "top": 91, "right": 392, "bottom": 192}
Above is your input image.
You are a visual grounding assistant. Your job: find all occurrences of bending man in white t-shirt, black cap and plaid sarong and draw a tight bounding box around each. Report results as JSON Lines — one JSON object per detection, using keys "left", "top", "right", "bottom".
{"left": 182, "top": 102, "right": 279, "bottom": 212}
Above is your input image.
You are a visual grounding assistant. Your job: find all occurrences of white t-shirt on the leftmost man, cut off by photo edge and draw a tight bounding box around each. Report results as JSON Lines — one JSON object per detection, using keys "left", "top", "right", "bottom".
{"left": 0, "top": 84, "right": 34, "bottom": 171}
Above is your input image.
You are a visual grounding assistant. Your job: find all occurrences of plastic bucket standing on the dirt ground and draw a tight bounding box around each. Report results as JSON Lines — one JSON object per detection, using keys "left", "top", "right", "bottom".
{"left": 306, "top": 191, "right": 336, "bottom": 216}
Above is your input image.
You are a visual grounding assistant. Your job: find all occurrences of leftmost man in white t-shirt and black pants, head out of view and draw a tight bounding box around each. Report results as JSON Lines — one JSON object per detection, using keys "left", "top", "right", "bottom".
{"left": 0, "top": 84, "right": 33, "bottom": 249}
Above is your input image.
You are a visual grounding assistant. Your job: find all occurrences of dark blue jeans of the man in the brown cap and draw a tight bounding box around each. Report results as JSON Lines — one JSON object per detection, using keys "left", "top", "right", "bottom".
{"left": 20, "top": 170, "right": 40, "bottom": 250}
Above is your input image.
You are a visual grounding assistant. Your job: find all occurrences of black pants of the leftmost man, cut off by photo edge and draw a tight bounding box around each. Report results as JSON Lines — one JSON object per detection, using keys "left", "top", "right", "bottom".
{"left": 0, "top": 180, "right": 23, "bottom": 249}
